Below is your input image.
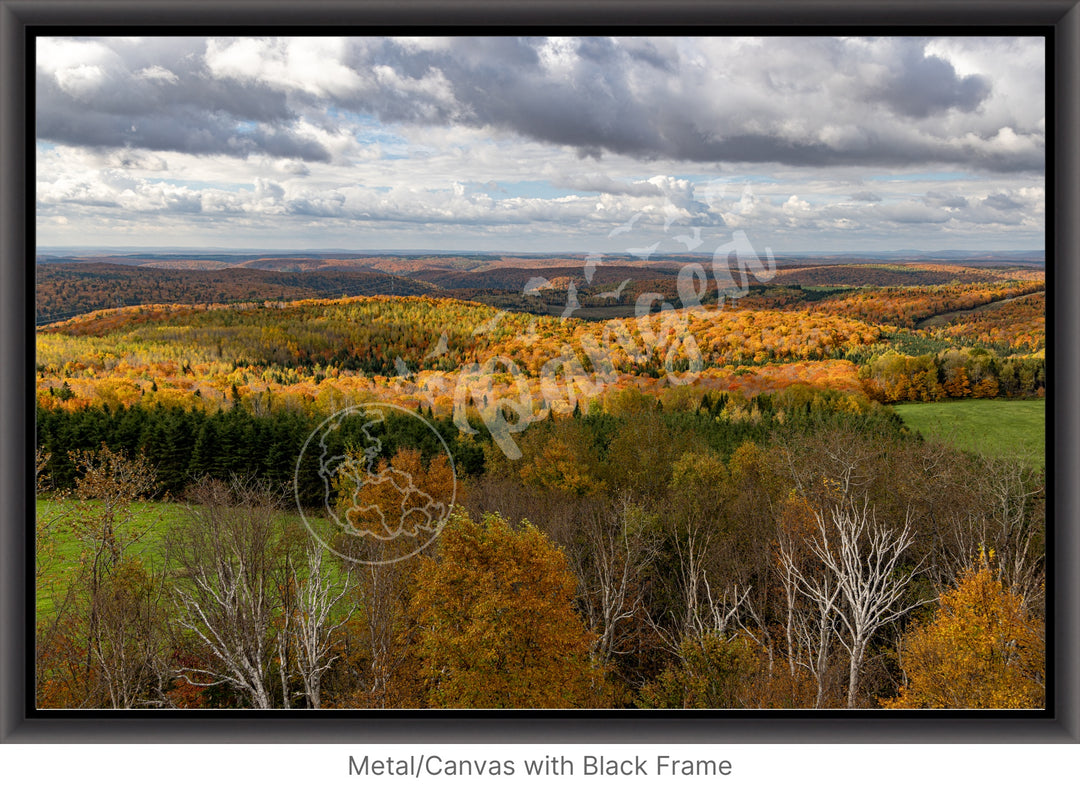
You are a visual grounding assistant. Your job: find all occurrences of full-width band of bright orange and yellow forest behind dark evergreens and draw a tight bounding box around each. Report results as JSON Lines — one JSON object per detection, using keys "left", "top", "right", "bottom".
{"left": 37, "top": 282, "right": 1044, "bottom": 425}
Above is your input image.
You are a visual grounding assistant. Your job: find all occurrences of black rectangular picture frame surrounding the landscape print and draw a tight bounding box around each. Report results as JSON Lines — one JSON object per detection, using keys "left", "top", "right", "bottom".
{"left": 0, "top": 0, "right": 1080, "bottom": 743}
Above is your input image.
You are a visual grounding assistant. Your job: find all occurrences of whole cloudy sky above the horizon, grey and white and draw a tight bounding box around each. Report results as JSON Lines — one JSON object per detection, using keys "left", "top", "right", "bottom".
{"left": 37, "top": 38, "right": 1045, "bottom": 253}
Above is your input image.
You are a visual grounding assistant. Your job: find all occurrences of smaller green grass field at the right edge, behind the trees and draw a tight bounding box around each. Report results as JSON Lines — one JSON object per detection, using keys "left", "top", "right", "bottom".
{"left": 893, "top": 398, "right": 1047, "bottom": 468}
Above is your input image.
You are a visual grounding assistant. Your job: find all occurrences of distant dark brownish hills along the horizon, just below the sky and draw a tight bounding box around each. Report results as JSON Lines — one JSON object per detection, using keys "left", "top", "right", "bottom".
{"left": 36, "top": 252, "right": 1044, "bottom": 325}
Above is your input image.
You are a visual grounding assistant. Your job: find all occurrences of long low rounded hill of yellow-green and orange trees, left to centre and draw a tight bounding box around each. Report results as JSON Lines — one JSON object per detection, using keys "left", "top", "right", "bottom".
{"left": 38, "top": 297, "right": 880, "bottom": 377}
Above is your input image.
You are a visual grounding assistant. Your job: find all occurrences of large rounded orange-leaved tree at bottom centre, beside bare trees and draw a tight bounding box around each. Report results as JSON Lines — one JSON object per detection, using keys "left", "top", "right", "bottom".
{"left": 411, "top": 513, "right": 603, "bottom": 707}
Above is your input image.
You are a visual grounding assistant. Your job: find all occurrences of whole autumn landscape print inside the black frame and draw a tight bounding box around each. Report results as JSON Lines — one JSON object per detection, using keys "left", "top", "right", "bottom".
{"left": 33, "top": 36, "right": 1048, "bottom": 717}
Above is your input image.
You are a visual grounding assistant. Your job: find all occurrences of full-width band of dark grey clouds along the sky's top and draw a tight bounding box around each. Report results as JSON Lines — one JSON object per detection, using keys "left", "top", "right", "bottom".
{"left": 38, "top": 37, "right": 1043, "bottom": 172}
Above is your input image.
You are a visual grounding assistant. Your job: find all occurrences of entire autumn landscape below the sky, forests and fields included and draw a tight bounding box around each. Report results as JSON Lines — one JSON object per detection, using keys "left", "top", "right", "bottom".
{"left": 33, "top": 253, "right": 1049, "bottom": 712}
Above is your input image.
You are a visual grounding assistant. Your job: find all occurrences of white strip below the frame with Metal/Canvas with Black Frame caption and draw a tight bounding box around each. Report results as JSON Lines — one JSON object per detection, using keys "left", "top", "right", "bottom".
{"left": 0, "top": 743, "right": 1080, "bottom": 798}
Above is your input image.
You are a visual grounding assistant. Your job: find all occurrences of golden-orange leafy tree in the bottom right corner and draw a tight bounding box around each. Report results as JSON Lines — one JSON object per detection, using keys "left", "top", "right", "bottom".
{"left": 882, "top": 556, "right": 1045, "bottom": 708}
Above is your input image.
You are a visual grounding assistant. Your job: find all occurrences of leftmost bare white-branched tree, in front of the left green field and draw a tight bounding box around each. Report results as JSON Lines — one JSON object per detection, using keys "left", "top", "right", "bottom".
{"left": 171, "top": 479, "right": 280, "bottom": 708}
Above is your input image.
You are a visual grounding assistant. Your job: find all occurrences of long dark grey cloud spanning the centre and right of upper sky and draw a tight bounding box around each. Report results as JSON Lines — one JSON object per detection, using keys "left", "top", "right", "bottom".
{"left": 342, "top": 39, "right": 1043, "bottom": 172}
